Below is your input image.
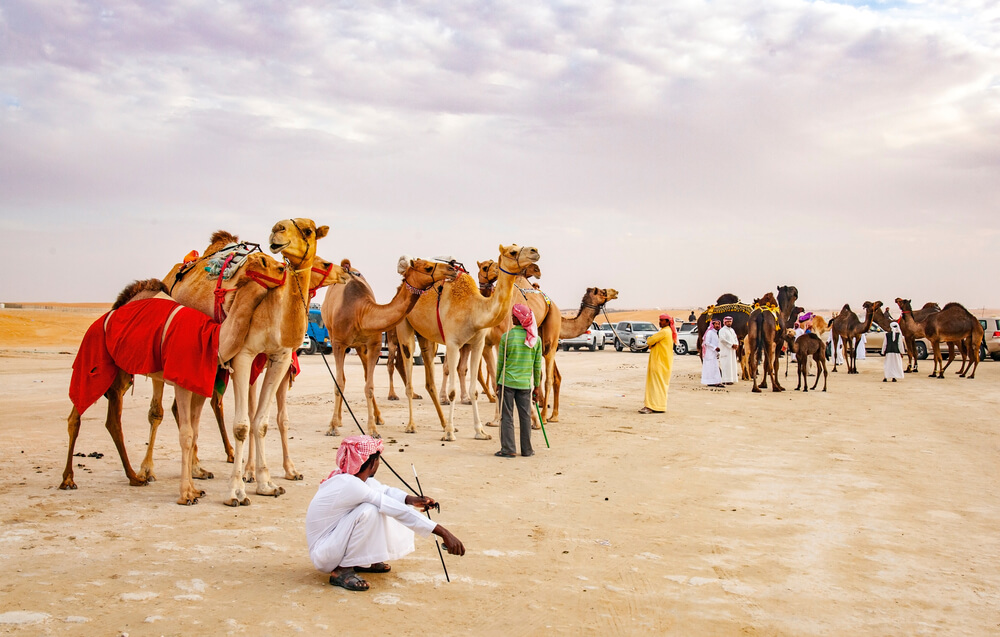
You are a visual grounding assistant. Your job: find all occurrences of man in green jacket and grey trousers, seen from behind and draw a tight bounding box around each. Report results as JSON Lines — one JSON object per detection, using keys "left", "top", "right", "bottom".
{"left": 494, "top": 303, "right": 542, "bottom": 458}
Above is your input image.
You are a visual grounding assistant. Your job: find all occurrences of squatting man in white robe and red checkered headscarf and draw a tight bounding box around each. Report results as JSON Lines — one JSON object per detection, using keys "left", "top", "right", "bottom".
{"left": 306, "top": 436, "right": 465, "bottom": 591}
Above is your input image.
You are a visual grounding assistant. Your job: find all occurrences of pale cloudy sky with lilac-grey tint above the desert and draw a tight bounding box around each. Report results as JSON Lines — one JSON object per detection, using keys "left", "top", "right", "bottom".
{"left": 0, "top": 0, "right": 1000, "bottom": 309}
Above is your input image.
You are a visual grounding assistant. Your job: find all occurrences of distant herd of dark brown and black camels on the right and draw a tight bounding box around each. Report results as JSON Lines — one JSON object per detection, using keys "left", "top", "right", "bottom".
{"left": 698, "top": 286, "right": 984, "bottom": 392}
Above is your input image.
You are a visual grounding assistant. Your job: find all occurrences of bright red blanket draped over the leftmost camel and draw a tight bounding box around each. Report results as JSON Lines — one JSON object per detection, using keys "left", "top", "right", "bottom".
{"left": 69, "top": 298, "right": 220, "bottom": 414}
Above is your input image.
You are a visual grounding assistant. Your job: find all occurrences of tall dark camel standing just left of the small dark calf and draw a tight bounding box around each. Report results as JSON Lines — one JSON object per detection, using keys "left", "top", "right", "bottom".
{"left": 748, "top": 285, "right": 799, "bottom": 393}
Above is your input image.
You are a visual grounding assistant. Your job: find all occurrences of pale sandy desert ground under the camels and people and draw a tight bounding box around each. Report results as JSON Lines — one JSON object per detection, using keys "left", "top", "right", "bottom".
{"left": 0, "top": 310, "right": 1000, "bottom": 635}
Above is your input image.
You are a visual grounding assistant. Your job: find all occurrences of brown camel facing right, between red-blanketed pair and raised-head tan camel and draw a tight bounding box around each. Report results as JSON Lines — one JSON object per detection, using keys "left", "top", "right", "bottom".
{"left": 321, "top": 257, "right": 458, "bottom": 438}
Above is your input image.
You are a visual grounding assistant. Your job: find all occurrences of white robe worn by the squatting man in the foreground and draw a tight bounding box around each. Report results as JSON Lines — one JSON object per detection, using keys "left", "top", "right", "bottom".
{"left": 306, "top": 473, "right": 437, "bottom": 573}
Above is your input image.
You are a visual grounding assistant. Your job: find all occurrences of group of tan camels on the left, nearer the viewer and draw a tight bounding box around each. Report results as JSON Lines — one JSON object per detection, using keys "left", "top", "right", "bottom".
{"left": 59, "top": 218, "right": 618, "bottom": 506}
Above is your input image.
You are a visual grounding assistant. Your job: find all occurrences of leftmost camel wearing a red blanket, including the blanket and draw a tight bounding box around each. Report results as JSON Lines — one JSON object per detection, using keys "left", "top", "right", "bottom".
{"left": 59, "top": 254, "right": 285, "bottom": 504}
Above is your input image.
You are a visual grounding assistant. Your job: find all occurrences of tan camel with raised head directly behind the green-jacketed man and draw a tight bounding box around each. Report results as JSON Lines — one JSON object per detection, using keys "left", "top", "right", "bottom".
{"left": 396, "top": 245, "right": 539, "bottom": 441}
